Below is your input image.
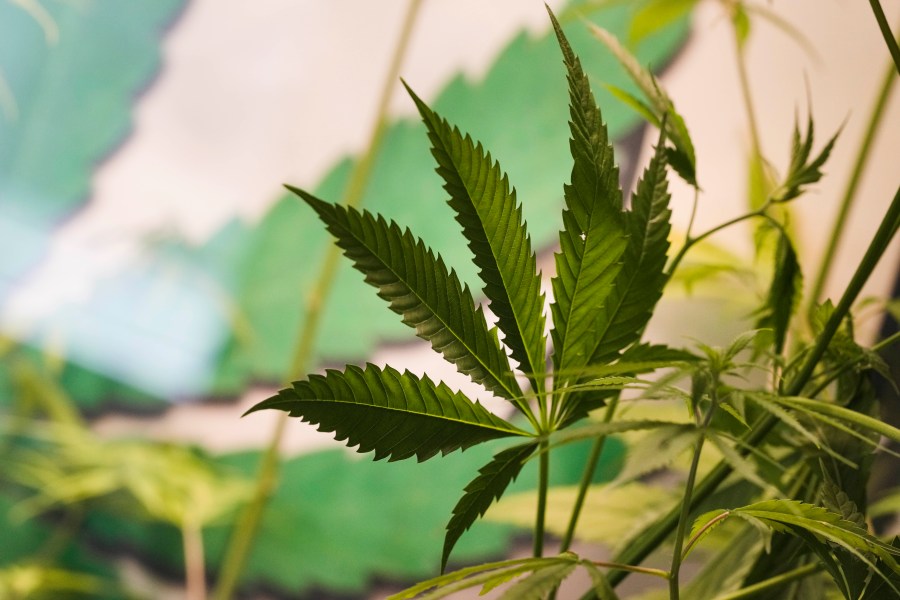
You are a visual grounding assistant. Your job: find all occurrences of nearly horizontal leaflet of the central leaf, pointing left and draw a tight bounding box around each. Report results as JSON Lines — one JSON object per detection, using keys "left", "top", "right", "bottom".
{"left": 247, "top": 364, "right": 528, "bottom": 462}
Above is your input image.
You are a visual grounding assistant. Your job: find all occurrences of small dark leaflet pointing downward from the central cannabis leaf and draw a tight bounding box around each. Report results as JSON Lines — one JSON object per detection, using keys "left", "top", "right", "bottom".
{"left": 441, "top": 442, "right": 538, "bottom": 573}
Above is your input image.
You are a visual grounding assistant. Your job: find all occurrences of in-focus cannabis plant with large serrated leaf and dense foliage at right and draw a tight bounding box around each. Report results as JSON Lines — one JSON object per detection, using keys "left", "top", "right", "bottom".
{"left": 248, "top": 5, "right": 900, "bottom": 598}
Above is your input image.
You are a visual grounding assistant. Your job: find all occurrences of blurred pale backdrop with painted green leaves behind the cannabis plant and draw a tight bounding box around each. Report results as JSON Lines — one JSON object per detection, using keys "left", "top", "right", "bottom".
{"left": 0, "top": 0, "right": 900, "bottom": 598}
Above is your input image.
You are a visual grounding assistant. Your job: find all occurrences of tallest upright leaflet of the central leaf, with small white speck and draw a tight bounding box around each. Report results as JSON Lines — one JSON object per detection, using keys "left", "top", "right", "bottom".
{"left": 550, "top": 8, "right": 627, "bottom": 388}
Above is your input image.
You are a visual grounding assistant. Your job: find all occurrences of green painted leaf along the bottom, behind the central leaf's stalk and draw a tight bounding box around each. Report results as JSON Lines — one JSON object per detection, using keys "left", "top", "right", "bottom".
{"left": 81, "top": 439, "right": 625, "bottom": 597}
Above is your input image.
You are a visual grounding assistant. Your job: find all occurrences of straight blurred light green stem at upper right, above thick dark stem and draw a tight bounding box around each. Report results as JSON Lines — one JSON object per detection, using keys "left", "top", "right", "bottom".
{"left": 808, "top": 56, "right": 897, "bottom": 316}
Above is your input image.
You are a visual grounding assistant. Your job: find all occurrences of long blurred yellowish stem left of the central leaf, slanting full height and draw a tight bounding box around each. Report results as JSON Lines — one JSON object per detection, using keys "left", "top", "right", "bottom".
{"left": 215, "top": 0, "right": 422, "bottom": 600}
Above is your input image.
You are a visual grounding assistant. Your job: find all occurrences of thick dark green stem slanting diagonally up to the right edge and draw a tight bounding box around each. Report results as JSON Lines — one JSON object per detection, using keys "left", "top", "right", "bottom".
{"left": 587, "top": 189, "right": 900, "bottom": 597}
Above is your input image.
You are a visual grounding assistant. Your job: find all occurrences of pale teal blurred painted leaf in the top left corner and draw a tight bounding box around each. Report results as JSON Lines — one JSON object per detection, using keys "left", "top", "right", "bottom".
{"left": 0, "top": 0, "right": 184, "bottom": 302}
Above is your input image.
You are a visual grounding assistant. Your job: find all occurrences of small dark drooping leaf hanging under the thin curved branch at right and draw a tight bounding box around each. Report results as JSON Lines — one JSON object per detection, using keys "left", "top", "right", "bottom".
{"left": 756, "top": 232, "right": 803, "bottom": 354}
